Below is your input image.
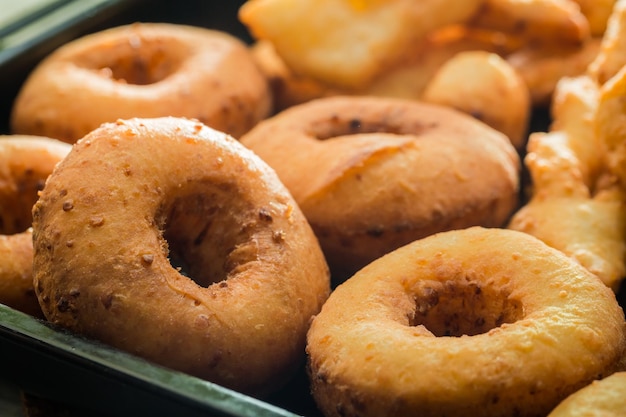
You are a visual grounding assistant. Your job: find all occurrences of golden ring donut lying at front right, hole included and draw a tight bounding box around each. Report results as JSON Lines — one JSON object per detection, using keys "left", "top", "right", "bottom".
{"left": 307, "top": 226, "right": 625, "bottom": 417}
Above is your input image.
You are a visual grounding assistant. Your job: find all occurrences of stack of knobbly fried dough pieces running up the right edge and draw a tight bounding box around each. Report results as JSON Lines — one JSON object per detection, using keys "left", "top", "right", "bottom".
{"left": 509, "top": 0, "right": 626, "bottom": 291}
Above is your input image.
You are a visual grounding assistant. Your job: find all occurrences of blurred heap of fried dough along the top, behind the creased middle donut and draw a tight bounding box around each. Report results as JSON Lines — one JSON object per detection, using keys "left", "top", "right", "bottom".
{"left": 239, "top": 0, "right": 615, "bottom": 151}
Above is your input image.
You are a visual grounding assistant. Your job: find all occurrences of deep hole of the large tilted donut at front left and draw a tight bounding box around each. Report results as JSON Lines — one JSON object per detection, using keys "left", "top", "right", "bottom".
{"left": 163, "top": 184, "right": 259, "bottom": 287}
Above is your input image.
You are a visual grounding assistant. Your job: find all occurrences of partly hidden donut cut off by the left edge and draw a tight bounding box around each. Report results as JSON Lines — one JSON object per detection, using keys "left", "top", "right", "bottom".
{"left": 0, "top": 135, "right": 71, "bottom": 317}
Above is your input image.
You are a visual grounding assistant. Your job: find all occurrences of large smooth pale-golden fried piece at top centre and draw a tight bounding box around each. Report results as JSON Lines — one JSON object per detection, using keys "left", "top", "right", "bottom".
{"left": 239, "top": 0, "right": 482, "bottom": 89}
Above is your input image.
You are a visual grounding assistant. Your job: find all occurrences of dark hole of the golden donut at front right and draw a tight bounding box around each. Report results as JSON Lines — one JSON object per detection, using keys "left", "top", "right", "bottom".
{"left": 410, "top": 280, "right": 523, "bottom": 337}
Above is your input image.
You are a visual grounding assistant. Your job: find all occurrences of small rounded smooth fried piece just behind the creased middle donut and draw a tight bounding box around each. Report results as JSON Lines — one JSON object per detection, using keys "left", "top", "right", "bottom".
{"left": 422, "top": 50, "right": 531, "bottom": 151}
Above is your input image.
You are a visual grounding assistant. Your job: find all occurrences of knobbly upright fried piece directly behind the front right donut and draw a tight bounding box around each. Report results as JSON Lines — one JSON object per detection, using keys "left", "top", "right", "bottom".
{"left": 509, "top": 76, "right": 626, "bottom": 291}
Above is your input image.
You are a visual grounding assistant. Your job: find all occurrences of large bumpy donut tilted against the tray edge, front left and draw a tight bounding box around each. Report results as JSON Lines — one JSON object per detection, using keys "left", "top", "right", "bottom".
{"left": 33, "top": 117, "right": 330, "bottom": 396}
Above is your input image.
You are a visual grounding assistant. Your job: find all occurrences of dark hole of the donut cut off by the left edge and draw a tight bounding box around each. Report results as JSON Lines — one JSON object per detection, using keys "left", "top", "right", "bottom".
{"left": 0, "top": 167, "right": 46, "bottom": 235}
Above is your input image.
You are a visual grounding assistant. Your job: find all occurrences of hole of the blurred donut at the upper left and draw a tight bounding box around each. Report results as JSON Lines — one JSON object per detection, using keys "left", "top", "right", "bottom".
{"left": 78, "top": 36, "right": 187, "bottom": 85}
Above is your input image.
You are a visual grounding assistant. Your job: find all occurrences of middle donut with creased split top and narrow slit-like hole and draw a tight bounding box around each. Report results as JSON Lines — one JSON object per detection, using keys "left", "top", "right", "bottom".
{"left": 240, "top": 96, "right": 521, "bottom": 280}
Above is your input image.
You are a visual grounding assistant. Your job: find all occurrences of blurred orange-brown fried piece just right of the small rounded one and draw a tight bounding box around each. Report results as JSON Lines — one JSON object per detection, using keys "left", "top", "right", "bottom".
{"left": 505, "top": 38, "right": 601, "bottom": 107}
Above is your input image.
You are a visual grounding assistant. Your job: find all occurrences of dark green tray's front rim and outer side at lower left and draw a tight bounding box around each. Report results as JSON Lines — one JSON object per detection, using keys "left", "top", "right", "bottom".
{"left": 0, "top": 304, "right": 304, "bottom": 417}
